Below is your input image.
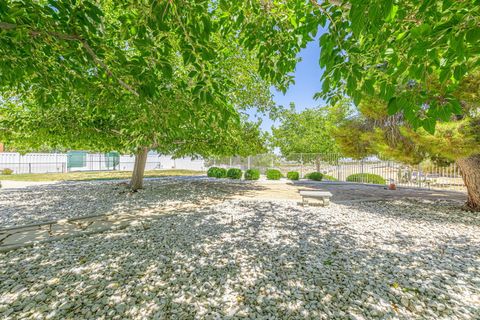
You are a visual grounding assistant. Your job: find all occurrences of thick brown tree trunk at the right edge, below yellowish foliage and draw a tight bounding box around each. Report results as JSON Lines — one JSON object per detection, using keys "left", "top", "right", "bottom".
{"left": 457, "top": 154, "right": 480, "bottom": 211}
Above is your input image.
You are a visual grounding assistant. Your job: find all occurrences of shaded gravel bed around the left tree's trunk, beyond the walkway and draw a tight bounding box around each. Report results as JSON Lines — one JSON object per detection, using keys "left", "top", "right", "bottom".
{"left": 0, "top": 177, "right": 268, "bottom": 229}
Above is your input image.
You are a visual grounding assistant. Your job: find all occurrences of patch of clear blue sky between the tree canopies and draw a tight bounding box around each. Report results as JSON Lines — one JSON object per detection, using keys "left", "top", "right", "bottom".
{"left": 253, "top": 30, "right": 323, "bottom": 131}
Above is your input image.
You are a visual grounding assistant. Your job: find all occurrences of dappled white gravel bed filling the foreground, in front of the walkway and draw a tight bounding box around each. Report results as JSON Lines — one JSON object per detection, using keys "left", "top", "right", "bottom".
{"left": 0, "top": 191, "right": 480, "bottom": 319}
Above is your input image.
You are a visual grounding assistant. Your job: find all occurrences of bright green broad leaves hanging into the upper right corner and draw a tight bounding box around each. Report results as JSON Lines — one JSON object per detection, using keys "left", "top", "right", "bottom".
{"left": 312, "top": 0, "right": 480, "bottom": 133}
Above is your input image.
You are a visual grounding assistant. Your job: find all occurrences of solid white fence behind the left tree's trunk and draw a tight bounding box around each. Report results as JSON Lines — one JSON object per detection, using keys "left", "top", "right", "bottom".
{"left": 0, "top": 152, "right": 205, "bottom": 174}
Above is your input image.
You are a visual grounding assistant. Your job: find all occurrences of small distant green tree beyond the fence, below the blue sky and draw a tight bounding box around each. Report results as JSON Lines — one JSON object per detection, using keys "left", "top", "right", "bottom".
{"left": 272, "top": 103, "right": 345, "bottom": 171}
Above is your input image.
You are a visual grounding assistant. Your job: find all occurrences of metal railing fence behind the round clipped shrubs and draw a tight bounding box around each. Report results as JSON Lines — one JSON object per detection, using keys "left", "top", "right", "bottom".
{"left": 206, "top": 153, "right": 466, "bottom": 191}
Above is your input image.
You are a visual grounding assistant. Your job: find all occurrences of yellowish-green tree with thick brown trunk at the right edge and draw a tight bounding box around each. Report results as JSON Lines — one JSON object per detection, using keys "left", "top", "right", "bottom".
{"left": 334, "top": 74, "right": 480, "bottom": 211}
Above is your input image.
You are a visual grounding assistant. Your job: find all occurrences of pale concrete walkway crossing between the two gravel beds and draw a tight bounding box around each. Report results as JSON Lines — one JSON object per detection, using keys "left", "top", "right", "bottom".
{"left": 0, "top": 180, "right": 466, "bottom": 252}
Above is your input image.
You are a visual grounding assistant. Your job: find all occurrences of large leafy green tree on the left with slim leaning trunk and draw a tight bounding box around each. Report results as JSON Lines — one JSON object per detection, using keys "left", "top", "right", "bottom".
{"left": 0, "top": 0, "right": 316, "bottom": 190}
